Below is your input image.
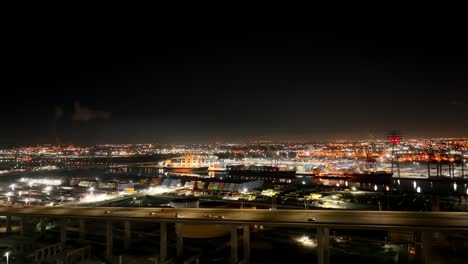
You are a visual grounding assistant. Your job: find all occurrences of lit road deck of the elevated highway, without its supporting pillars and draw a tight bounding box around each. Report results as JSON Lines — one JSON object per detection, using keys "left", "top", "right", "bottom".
{"left": 0, "top": 207, "right": 468, "bottom": 230}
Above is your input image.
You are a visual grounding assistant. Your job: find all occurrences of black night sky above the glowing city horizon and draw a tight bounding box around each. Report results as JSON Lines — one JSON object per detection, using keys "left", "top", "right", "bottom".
{"left": 4, "top": 3, "right": 468, "bottom": 144}
